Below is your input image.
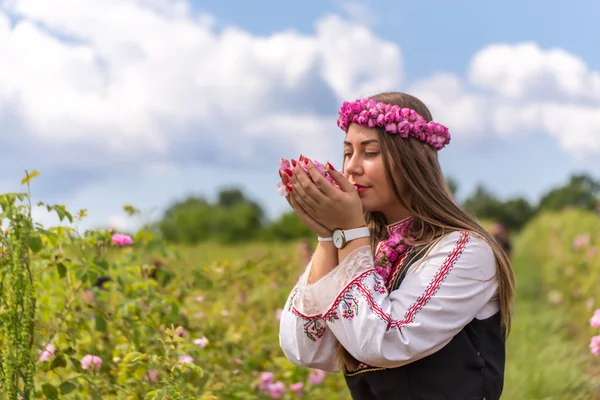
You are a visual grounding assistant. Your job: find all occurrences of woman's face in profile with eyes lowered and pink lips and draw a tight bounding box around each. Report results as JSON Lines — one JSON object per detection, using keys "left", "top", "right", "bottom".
{"left": 344, "top": 123, "right": 405, "bottom": 223}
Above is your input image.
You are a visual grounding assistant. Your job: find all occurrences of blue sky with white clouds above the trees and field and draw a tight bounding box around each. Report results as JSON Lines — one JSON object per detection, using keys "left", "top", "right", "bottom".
{"left": 0, "top": 0, "right": 600, "bottom": 229}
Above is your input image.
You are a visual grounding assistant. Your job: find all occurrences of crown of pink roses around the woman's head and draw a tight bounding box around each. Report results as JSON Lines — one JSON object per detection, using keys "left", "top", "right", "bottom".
{"left": 337, "top": 99, "right": 450, "bottom": 150}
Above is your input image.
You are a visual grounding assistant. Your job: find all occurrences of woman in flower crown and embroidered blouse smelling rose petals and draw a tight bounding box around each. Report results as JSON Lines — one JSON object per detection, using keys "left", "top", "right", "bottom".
{"left": 280, "top": 93, "right": 514, "bottom": 400}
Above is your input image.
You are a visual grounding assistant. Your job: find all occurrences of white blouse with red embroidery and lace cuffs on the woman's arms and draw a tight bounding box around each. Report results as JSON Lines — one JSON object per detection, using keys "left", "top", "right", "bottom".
{"left": 279, "top": 228, "right": 499, "bottom": 372}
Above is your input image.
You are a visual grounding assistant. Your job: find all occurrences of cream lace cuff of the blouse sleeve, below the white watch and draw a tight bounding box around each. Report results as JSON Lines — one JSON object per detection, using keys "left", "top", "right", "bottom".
{"left": 293, "top": 246, "right": 374, "bottom": 316}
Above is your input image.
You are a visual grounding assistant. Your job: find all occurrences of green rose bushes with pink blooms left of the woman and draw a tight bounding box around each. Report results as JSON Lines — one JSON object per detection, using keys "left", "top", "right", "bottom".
{"left": 0, "top": 174, "right": 345, "bottom": 400}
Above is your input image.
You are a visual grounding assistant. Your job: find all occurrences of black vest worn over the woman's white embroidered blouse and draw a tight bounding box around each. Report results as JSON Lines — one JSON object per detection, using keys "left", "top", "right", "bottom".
{"left": 344, "top": 245, "right": 505, "bottom": 400}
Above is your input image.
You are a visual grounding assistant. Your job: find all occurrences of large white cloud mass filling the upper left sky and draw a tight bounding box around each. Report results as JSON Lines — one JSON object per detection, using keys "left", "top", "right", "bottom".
{"left": 0, "top": 0, "right": 402, "bottom": 166}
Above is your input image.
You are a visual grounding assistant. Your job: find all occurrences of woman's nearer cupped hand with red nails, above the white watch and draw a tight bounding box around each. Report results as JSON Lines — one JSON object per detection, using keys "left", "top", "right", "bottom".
{"left": 288, "top": 158, "right": 366, "bottom": 231}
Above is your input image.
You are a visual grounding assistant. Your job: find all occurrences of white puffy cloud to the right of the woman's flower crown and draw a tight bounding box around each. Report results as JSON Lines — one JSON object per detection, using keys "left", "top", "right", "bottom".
{"left": 408, "top": 43, "right": 600, "bottom": 158}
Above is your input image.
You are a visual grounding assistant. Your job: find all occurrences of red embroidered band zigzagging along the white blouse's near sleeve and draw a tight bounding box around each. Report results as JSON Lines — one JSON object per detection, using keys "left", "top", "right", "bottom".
{"left": 323, "top": 232, "right": 469, "bottom": 330}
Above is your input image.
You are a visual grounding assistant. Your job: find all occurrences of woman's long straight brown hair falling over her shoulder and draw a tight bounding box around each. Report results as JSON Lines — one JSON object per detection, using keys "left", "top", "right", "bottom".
{"left": 338, "top": 92, "right": 515, "bottom": 369}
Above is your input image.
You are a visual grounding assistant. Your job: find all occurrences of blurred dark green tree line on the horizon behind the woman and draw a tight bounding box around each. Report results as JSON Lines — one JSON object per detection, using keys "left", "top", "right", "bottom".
{"left": 154, "top": 174, "right": 600, "bottom": 245}
